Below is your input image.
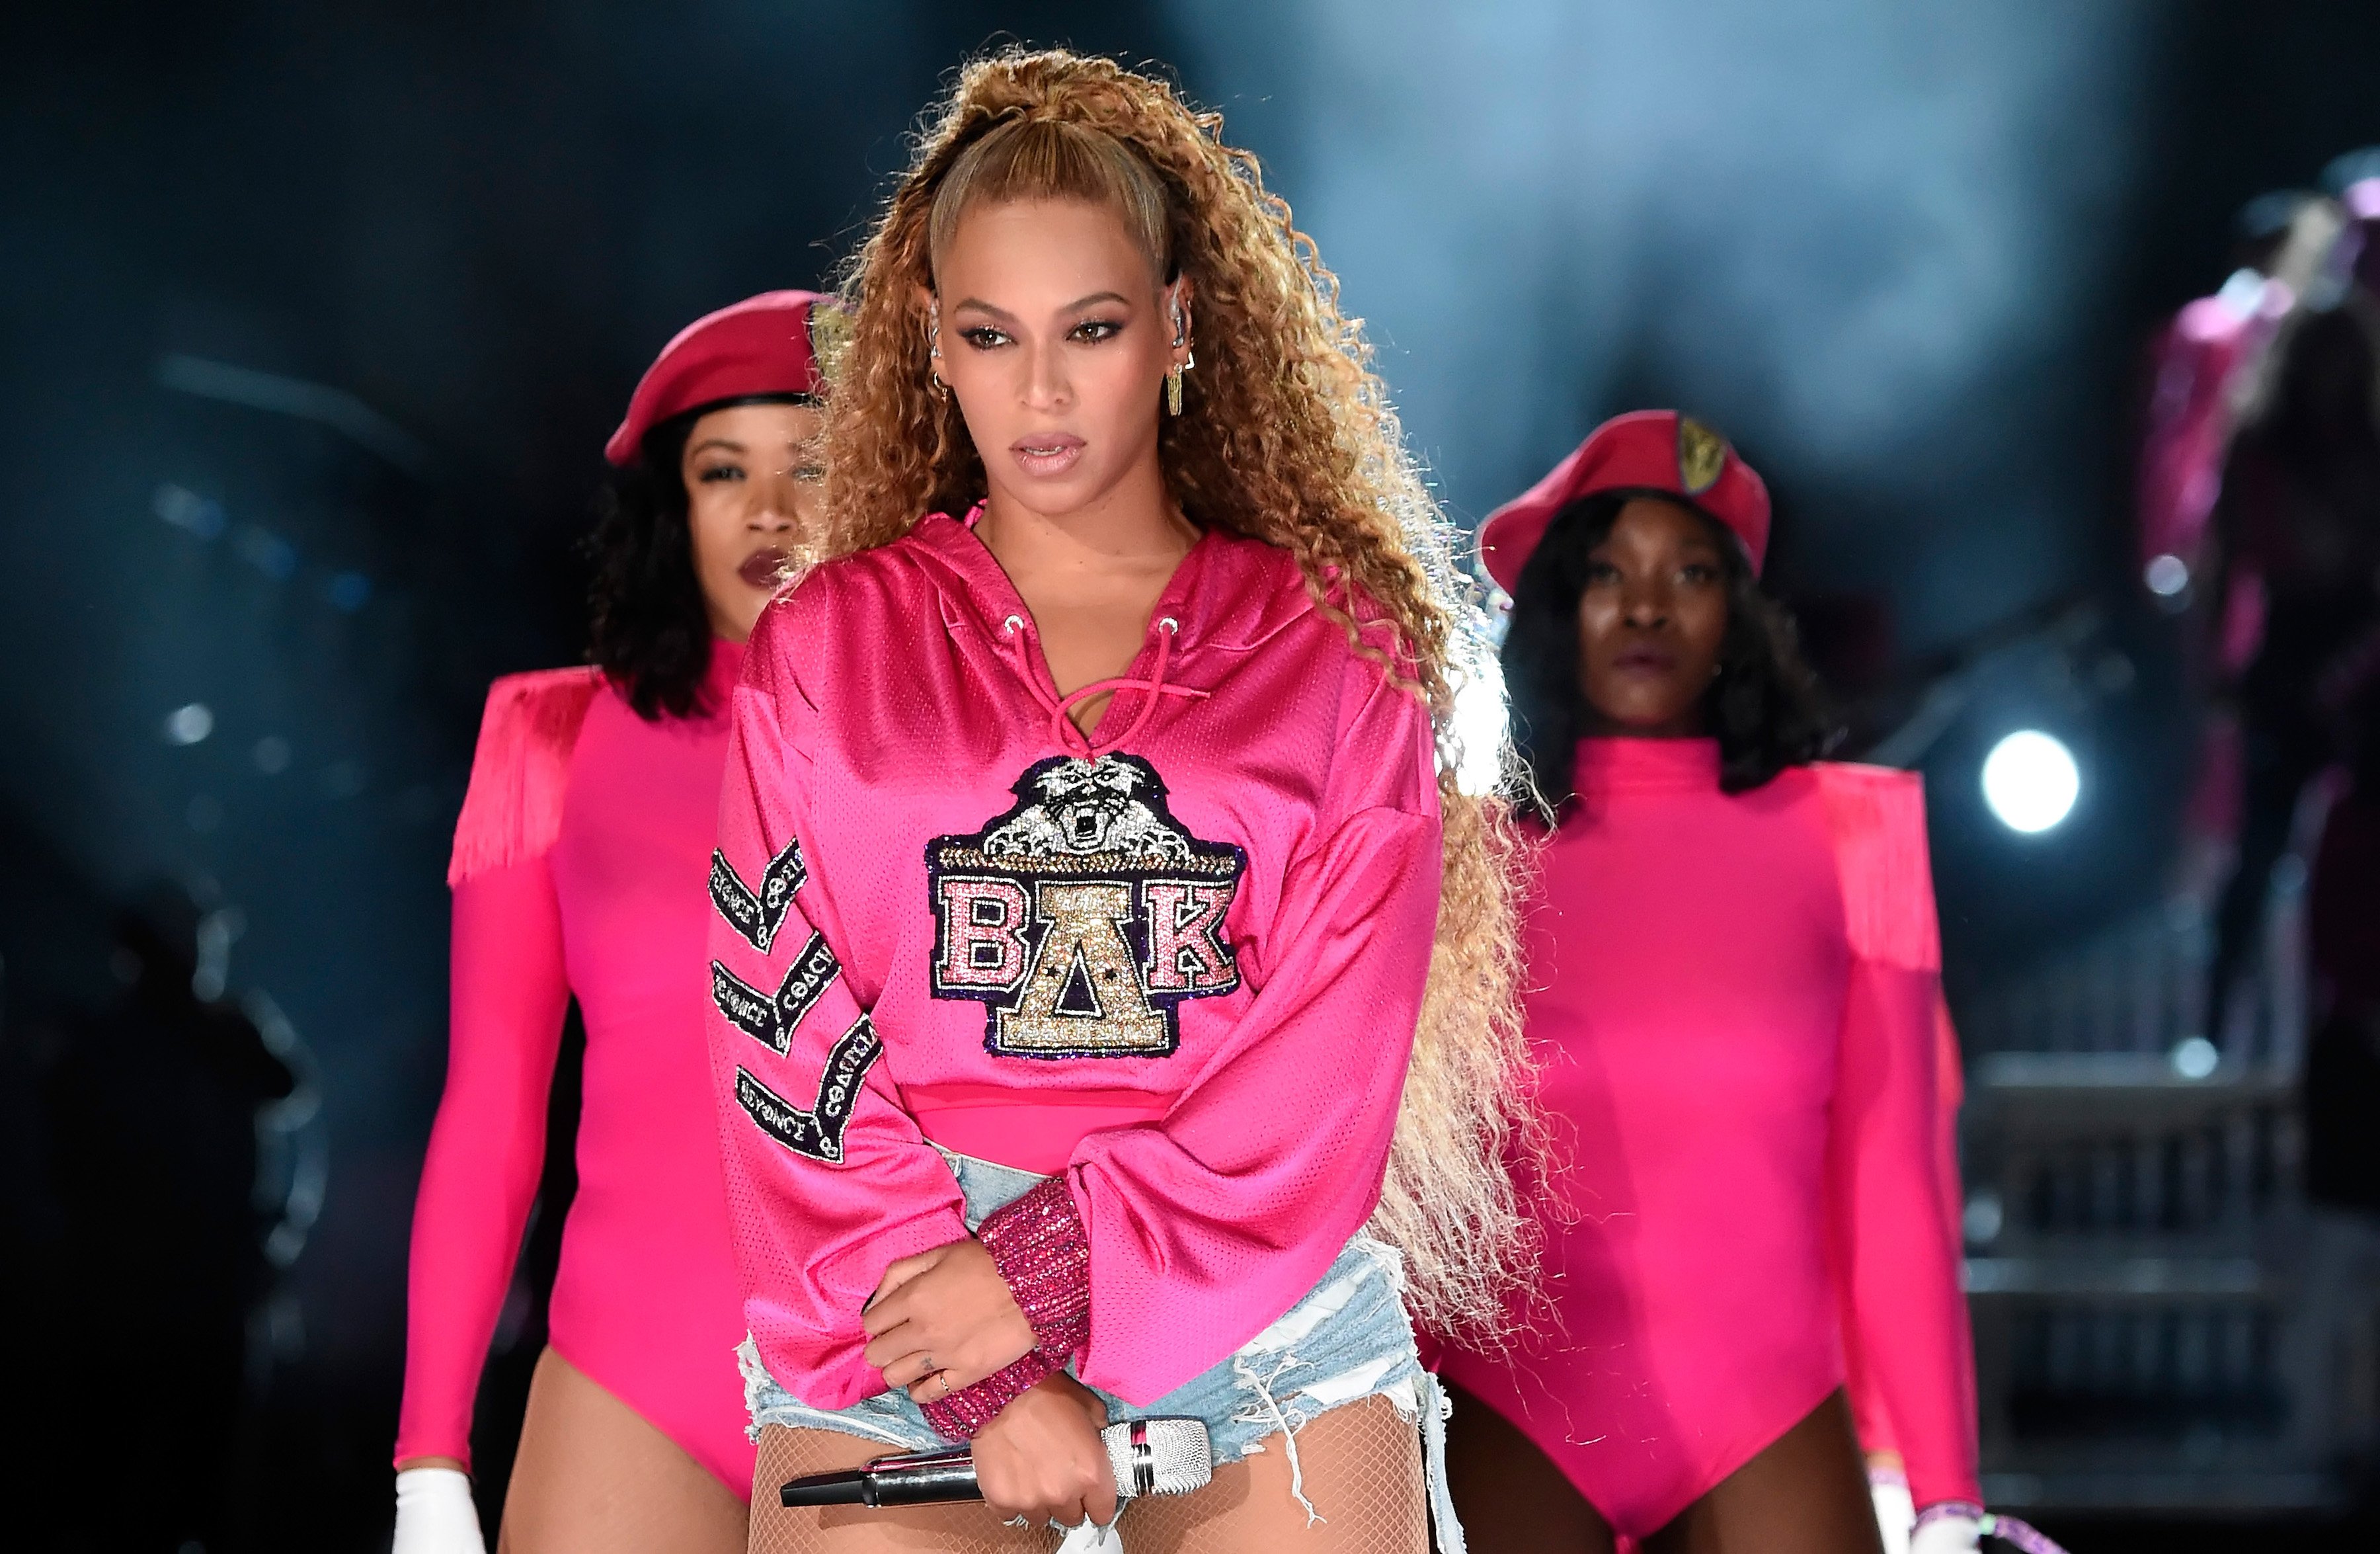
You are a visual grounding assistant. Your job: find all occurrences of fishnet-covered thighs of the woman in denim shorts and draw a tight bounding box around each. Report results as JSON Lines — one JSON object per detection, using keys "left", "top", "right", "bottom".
{"left": 750, "top": 1397, "right": 1428, "bottom": 1554}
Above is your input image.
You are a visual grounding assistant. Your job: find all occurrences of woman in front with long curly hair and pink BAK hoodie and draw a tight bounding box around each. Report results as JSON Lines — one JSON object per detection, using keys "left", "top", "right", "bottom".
{"left": 711, "top": 52, "right": 1519, "bottom": 1554}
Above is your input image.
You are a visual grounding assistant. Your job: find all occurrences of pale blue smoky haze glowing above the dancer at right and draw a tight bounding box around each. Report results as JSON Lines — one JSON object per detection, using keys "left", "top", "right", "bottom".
{"left": 1175, "top": 0, "right": 2157, "bottom": 647}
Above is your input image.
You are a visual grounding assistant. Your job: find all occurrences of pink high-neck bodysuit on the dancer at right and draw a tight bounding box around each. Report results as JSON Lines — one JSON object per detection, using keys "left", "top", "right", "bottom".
{"left": 1447, "top": 740, "right": 1978, "bottom": 1537}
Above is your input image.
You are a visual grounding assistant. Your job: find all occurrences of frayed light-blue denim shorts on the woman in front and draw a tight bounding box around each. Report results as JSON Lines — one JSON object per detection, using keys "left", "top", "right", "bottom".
{"left": 735, "top": 1149, "right": 1461, "bottom": 1554}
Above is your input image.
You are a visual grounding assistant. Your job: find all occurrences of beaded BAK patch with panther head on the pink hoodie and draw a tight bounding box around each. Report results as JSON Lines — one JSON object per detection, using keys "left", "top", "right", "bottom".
{"left": 926, "top": 755, "right": 1247, "bottom": 1057}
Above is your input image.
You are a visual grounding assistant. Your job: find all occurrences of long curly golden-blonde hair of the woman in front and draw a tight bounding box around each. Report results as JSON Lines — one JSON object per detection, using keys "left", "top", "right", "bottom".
{"left": 821, "top": 50, "right": 1540, "bottom": 1342}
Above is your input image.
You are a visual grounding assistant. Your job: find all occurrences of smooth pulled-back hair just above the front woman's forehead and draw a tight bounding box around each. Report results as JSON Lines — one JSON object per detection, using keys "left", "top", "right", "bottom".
{"left": 926, "top": 119, "right": 1173, "bottom": 286}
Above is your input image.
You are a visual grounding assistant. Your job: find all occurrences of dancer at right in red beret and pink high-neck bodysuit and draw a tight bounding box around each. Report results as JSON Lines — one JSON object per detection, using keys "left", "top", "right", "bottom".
{"left": 1445, "top": 412, "right": 2056, "bottom": 1554}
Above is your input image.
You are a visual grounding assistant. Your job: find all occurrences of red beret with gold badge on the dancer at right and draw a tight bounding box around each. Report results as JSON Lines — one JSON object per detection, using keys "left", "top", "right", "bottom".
{"left": 1480, "top": 409, "right": 1768, "bottom": 593}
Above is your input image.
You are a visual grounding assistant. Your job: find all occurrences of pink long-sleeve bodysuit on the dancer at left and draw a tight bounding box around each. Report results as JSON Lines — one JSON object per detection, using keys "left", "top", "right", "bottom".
{"left": 397, "top": 643, "right": 754, "bottom": 1497}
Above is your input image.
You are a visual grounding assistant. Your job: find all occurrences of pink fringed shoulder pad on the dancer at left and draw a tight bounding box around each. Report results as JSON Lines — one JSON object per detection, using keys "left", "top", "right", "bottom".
{"left": 448, "top": 667, "right": 602, "bottom": 887}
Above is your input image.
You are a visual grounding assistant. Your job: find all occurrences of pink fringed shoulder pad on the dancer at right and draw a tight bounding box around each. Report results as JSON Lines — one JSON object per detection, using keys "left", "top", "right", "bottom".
{"left": 1811, "top": 762, "right": 1942, "bottom": 971}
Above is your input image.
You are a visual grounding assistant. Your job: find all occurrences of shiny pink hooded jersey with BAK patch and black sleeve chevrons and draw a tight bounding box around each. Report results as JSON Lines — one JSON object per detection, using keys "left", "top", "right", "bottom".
{"left": 711, "top": 514, "right": 1440, "bottom": 1428}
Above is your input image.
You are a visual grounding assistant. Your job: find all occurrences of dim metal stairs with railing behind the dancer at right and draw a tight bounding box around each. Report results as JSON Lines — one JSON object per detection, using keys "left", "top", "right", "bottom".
{"left": 1961, "top": 871, "right": 2380, "bottom": 1516}
